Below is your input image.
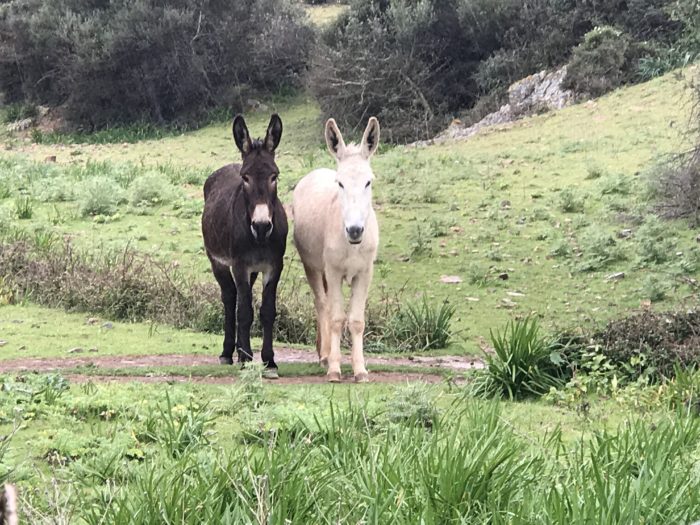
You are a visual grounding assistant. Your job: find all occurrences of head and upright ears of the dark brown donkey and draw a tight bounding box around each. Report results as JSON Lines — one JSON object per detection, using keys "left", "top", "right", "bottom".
{"left": 233, "top": 115, "right": 282, "bottom": 243}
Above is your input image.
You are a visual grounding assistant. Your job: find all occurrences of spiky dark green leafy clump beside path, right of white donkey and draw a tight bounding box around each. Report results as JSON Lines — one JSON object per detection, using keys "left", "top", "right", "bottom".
{"left": 472, "top": 318, "right": 567, "bottom": 400}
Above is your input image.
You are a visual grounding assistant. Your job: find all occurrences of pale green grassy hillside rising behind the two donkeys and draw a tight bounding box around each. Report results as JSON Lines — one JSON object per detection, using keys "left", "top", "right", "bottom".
{"left": 0, "top": 67, "right": 700, "bottom": 352}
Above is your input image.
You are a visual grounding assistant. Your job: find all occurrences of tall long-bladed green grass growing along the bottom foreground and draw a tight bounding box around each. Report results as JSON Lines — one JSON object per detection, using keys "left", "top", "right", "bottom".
{"left": 23, "top": 400, "right": 700, "bottom": 525}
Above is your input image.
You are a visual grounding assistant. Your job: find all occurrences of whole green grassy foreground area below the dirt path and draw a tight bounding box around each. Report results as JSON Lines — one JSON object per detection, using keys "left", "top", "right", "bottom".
{"left": 0, "top": 375, "right": 700, "bottom": 524}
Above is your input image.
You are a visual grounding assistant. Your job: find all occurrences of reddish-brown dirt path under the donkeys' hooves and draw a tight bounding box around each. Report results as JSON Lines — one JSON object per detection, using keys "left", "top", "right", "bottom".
{"left": 0, "top": 348, "right": 484, "bottom": 384}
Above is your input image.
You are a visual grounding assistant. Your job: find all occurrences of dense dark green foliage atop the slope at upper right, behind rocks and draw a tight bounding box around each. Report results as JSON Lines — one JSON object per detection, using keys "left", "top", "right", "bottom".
{"left": 311, "top": 0, "right": 700, "bottom": 142}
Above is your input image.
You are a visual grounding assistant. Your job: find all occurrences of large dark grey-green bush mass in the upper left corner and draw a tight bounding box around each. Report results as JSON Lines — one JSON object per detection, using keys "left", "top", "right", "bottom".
{"left": 0, "top": 0, "right": 313, "bottom": 130}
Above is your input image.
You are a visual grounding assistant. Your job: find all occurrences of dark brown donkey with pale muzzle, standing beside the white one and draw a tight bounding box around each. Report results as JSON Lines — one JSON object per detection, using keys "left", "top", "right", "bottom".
{"left": 202, "top": 115, "right": 288, "bottom": 377}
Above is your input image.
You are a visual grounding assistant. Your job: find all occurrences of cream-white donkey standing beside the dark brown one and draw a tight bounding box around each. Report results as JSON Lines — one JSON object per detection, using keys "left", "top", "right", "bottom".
{"left": 292, "top": 117, "right": 379, "bottom": 382}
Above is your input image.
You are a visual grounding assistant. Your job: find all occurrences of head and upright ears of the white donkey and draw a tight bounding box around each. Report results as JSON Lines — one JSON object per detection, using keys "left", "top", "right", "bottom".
{"left": 326, "top": 117, "right": 379, "bottom": 244}
